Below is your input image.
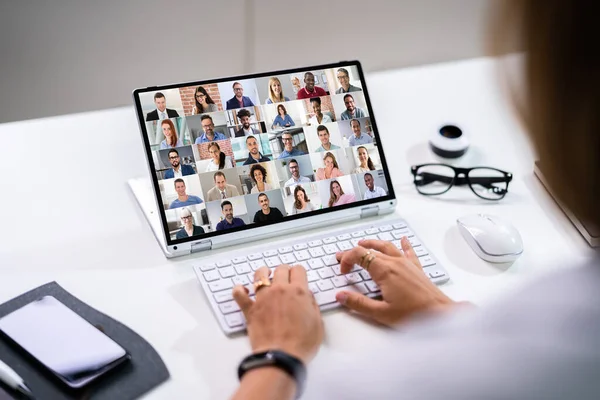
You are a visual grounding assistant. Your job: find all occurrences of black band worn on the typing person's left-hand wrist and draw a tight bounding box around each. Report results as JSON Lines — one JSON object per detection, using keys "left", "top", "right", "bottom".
{"left": 238, "top": 350, "right": 306, "bottom": 398}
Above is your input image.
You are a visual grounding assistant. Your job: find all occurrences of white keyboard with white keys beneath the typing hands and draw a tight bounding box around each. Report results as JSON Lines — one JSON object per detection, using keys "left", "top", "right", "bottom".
{"left": 194, "top": 220, "right": 449, "bottom": 334}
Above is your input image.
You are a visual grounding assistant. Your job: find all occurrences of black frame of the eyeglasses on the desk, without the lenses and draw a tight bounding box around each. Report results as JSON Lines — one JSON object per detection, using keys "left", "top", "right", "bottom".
{"left": 410, "top": 163, "right": 513, "bottom": 201}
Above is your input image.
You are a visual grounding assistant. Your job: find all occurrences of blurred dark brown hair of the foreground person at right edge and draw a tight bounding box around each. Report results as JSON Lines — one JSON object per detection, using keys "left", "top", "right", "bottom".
{"left": 492, "top": 0, "right": 600, "bottom": 226}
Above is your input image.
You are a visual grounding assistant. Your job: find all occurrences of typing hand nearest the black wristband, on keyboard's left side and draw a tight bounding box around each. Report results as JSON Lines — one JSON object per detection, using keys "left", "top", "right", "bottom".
{"left": 233, "top": 265, "right": 323, "bottom": 364}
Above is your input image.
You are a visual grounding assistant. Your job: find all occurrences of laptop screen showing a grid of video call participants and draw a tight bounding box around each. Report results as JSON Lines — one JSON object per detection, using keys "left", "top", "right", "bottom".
{"left": 134, "top": 62, "right": 394, "bottom": 245}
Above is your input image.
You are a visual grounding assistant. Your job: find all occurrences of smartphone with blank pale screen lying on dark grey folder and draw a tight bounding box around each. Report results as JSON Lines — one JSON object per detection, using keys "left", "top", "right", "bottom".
{"left": 0, "top": 296, "right": 131, "bottom": 389}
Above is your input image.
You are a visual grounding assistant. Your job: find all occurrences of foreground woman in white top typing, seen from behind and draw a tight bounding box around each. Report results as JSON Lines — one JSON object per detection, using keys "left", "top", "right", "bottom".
{"left": 232, "top": 0, "right": 600, "bottom": 400}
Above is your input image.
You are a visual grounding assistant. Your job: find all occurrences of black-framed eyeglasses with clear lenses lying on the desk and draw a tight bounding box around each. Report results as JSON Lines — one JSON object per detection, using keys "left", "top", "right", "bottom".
{"left": 411, "top": 164, "right": 512, "bottom": 200}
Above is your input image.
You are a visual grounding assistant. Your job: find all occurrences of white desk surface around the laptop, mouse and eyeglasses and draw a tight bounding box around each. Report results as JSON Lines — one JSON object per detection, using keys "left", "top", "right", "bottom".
{"left": 0, "top": 55, "right": 590, "bottom": 399}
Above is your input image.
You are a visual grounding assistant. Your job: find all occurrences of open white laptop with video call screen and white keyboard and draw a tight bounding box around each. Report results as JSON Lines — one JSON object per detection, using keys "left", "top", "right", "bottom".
{"left": 129, "top": 61, "right": 449, "bottom": 334}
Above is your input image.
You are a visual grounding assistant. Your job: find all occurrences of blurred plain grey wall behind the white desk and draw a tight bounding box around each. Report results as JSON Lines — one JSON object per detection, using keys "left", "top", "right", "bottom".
{"left": 0, "top": 0, "right": 516, "bottom": 122}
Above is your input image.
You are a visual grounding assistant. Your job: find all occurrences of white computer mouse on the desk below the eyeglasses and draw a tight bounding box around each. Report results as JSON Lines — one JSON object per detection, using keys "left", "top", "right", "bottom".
{"left": 456, "top": 214, "right": 523, "bottom": 263}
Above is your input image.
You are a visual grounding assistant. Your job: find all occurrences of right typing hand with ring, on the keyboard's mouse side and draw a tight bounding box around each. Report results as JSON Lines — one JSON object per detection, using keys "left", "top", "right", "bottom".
{"left": 336, "top": 237, "right": 456, "bottom": 325}
